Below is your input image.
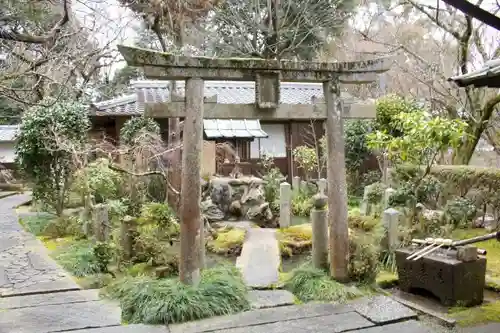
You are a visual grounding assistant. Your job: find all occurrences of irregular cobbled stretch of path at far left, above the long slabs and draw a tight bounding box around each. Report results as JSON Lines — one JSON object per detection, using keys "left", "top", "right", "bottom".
{"left": 0, "top": 194, "right": 80, "bottom": 296}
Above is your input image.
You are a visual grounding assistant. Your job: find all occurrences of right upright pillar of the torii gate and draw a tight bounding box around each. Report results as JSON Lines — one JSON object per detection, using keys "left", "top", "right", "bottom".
{"left": 323, "top": 77, "right": 349, "bottom": 282}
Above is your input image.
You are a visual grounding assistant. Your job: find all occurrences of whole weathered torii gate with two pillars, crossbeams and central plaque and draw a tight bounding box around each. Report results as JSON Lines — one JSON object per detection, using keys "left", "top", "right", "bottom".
{"left": 118, "top": 45, "right": 391, "bottom": 284}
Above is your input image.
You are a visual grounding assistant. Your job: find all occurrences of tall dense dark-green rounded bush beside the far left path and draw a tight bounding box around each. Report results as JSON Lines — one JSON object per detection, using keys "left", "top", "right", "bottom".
{"left": 16, "top": 98, "right": 90, "bottom": 215}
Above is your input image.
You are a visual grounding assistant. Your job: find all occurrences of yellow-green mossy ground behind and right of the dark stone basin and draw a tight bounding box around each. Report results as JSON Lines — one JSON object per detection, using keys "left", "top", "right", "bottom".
{"left": 452, "top": 229, "right": 500, "bottom": 278}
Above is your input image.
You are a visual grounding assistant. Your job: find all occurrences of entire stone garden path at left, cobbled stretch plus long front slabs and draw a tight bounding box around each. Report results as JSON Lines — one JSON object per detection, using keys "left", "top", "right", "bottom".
{"left": 0, "top": 194, "right": 167, "bottom": 333}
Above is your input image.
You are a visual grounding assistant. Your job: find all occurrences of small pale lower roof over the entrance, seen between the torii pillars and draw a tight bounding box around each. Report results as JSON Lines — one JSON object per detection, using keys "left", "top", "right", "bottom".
{"left": 203, "top": 119, "right": 268, "bottom": 139}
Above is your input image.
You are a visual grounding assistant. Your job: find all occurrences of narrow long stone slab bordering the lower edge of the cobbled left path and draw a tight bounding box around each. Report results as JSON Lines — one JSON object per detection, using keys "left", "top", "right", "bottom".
{"left": 0, "top": 289, "right": 99, "bottom": 311}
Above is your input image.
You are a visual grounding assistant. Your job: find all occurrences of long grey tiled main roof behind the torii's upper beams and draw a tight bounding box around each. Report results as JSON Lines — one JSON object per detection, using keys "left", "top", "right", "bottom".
{"left": 93, "top": 80, "right": 353, "bottom": 116}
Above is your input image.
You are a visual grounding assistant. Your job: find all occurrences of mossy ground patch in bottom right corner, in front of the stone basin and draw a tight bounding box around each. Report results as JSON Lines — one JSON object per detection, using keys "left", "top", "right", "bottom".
{"left": 450, "top": 301, "right": 500, "bottom": 326}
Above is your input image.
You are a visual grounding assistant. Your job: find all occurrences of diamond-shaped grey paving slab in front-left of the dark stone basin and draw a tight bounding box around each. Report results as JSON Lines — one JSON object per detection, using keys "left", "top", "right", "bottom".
{"left": 349, "top": 296, "right": 417, "bottom": 324}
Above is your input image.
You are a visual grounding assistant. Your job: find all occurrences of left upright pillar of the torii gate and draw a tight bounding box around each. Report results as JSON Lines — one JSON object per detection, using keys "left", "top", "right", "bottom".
{"left": 179, "top": 78, "right": 205, "bottom": 284}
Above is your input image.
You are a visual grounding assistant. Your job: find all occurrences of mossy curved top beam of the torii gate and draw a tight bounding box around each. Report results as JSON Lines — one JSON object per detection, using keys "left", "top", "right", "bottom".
{"left": 118, "top": 45, "right": 392, "bottom": 83}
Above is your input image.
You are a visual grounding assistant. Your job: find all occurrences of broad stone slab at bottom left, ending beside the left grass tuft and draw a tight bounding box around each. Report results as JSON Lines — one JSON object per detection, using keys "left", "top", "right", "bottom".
{"left": 0, "top": 301, "right": 121, "bottom": 333}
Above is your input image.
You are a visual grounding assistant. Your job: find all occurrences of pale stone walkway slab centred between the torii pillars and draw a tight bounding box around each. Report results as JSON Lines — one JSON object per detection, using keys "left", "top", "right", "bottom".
{"left": 236, "top": 228, "right": 281, "bottom": 289}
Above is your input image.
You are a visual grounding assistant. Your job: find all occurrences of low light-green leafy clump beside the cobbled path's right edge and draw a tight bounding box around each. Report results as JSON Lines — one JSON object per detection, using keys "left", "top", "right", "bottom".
{"left": 53, "top": 241, "right": 112, "bottom": 277}
